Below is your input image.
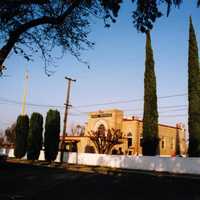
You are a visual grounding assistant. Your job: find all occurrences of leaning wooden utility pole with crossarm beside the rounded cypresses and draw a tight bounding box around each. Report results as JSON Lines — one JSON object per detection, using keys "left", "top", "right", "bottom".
{"left": 60, "top": 77, "right": 76, "bottom": 163}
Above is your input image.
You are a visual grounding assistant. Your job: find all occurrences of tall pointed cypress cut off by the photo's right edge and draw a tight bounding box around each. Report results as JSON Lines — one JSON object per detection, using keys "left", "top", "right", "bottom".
{"left": 188, "top": 17, "right": 200, "bottom": 157}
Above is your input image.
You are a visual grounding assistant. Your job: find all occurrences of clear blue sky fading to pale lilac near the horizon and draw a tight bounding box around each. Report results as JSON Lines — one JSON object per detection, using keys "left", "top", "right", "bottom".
{"left": 0, "top": 0, "right": 200, "bottom": 134}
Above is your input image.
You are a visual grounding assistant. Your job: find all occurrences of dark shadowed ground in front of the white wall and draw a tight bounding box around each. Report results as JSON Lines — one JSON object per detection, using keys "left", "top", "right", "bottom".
{"left": 0, "top": 163, "right": 200, "bottom": 200}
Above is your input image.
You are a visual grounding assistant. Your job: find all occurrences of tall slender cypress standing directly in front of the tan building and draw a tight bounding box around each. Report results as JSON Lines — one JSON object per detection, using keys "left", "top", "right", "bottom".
{"left": 142, "top": 31, "right": 159, "bottom": 156}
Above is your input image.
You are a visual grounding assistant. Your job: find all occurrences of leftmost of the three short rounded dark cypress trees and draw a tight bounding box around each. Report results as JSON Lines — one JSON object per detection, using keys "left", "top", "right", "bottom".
{"left": 14, "top": 115, "right": 29, "bottom": 158}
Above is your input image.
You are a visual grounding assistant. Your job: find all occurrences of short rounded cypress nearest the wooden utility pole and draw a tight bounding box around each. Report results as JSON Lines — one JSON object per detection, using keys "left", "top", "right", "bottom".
{"left": 44, "top": 109, "right": 60, "bottom": 162}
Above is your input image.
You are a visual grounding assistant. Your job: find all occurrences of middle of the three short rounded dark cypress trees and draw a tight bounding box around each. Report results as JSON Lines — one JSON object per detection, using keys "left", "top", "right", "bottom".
{"left": 27, "top": 113, "right": 43, "bottom": 160}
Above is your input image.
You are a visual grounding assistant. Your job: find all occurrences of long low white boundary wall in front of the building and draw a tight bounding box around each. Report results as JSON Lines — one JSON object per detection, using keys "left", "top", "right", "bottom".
{"left": 2, "top": 150, "right": 200, "bottom": 174}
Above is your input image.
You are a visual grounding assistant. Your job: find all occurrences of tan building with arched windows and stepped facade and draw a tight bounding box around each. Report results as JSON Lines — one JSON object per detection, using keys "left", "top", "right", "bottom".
{"left": 65, "top": 109, "right": 187, "bottom": 156}
